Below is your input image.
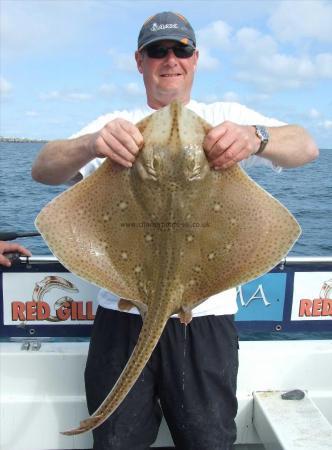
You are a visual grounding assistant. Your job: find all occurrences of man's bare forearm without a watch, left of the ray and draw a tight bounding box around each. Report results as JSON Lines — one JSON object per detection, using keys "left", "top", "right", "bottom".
{"left": 31, "top": 135, "right": 94, "bottom": 185}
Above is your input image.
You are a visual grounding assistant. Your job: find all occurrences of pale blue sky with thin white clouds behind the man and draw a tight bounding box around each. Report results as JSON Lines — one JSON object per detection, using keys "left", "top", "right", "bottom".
{"left": 0, "top": 0, "right": 332, "bottom": 148}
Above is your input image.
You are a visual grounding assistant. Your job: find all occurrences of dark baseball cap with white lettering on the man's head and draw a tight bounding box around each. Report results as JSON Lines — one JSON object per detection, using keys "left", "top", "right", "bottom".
{"left": 137, "top": 11, "right": 196, "bottom": 51}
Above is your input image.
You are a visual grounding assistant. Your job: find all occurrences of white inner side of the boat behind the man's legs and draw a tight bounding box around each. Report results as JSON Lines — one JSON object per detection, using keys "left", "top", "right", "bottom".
{"left": 0, "top": 340, "right": 332, "bottom": 450}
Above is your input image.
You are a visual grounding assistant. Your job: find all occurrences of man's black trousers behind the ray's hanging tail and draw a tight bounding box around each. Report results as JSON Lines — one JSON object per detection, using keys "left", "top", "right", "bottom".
{"left": 85, "top": 307, "right": 238, "bottom": 450}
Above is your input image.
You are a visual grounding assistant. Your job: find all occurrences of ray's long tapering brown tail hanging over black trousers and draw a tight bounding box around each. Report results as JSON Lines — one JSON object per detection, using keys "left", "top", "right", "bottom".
{"left": 61, "top": 309, "right": 170, "bottom": 436}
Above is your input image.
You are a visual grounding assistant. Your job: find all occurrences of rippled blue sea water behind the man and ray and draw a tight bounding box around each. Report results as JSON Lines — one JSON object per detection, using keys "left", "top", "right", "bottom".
{"left": 0, "top": 142, "right": 332, "bottom": 256}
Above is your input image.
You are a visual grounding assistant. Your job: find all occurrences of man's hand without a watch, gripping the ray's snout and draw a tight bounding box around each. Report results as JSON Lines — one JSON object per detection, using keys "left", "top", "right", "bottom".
{"left": 90, "top": 119, "right": 143, "bottom": 167}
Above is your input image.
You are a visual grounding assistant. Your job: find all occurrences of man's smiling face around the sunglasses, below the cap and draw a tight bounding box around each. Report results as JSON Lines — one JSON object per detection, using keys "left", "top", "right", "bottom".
{"left": 135, "top": 41, "right": 198, "bottom": 109}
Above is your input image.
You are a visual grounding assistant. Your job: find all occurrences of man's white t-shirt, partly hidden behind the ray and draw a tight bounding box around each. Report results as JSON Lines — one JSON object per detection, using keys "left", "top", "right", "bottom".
{"left": 71, "top": 100, "right": 285, "bottom": 317}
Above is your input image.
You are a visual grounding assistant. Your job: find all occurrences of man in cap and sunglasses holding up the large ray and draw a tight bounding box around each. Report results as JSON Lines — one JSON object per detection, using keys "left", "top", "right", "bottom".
{"left": 32, "top": 12, "right": 318, "bottom": 450}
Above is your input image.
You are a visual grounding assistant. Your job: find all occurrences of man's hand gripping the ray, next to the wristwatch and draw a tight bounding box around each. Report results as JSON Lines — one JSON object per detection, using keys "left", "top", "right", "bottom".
{"left": 203, "top": 122, "right": 260, "bottom": 170}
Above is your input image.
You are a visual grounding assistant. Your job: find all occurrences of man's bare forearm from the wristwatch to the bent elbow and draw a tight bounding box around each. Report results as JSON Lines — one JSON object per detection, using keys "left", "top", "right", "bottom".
{"left": 260, "top": 125, "right": 319, "bottom": 168}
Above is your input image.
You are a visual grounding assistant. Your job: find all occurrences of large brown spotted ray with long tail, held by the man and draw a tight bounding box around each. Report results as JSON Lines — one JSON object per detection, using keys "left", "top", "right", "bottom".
{"left": 36, "top": 102, "right": 300, "bottom": 435}
